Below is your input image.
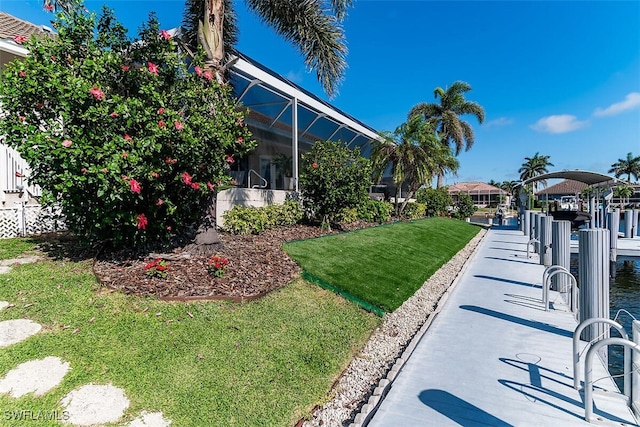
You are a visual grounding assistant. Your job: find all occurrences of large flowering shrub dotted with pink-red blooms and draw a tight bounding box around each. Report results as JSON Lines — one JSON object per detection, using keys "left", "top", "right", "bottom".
{"left": 0, "top": 7, "right": 255, "bottom": 247}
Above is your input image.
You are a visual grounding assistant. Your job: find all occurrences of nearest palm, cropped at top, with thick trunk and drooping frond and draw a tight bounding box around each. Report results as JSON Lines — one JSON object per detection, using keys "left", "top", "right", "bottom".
{"left": 43, "top": 0, "right": 353, "bottom": 97}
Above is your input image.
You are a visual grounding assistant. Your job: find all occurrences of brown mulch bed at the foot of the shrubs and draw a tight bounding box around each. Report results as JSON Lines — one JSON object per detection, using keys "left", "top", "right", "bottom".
{"left": 93, "top": 222, "right": 374, "bottom": 300}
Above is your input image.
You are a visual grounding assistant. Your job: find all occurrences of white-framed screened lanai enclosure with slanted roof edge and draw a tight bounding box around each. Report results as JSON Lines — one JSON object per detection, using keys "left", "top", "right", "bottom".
{"left": 230, "top": 53, "right": 377, "bottom": 190}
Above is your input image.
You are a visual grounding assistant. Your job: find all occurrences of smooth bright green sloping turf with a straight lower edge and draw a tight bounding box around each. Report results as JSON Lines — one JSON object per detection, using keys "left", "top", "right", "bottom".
{"left": 285, "top": 218, "right": 480, "bottom": 312}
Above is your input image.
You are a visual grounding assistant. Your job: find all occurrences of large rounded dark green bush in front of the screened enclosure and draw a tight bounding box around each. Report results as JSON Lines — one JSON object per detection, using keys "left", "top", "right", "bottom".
{"left": 300, "top": 141, "right": 372, "bottom": 225}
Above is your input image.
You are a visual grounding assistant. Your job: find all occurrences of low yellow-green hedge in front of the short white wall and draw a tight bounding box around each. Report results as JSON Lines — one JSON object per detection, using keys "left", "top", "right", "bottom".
{"left": 223, "top": 200, "right": 302, "bottom": 234}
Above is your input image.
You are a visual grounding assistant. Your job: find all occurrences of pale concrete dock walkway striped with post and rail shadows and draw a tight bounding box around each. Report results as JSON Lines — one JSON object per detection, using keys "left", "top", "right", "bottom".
{"left": 368, "top": 229, "right": 635, "bottom": 427}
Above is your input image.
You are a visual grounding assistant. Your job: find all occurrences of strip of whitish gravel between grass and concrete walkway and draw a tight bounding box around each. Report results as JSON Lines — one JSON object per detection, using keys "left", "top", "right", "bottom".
{"left": 303, "top": 229, "right": 487, "bottom": 427}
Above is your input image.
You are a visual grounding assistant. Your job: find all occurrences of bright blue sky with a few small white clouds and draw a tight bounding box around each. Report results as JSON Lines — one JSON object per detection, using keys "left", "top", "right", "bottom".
{"left": 5, "top": 0, "right": 640, "bottom": 184}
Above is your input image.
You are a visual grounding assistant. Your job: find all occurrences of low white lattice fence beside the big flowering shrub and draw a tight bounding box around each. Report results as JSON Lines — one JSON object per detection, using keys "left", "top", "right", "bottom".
{"left": 0, "top": 203, "right": 66, "bottom": 238}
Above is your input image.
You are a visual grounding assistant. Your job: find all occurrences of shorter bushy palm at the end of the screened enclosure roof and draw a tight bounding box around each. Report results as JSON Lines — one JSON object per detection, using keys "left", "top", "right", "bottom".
{"left": 371, "top": 116, "right": 458, "bottom": 215}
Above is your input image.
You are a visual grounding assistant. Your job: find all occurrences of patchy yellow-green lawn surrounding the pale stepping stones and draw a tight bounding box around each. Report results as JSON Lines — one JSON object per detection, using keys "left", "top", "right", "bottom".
{"left": 0, "top": 239, "right": 380, "bottom": 426}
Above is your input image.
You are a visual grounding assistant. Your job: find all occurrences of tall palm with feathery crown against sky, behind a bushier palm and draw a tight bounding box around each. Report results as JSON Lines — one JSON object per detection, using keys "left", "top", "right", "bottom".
{"left": 409, "top": 81, "right": 484, "bottom": 187}
